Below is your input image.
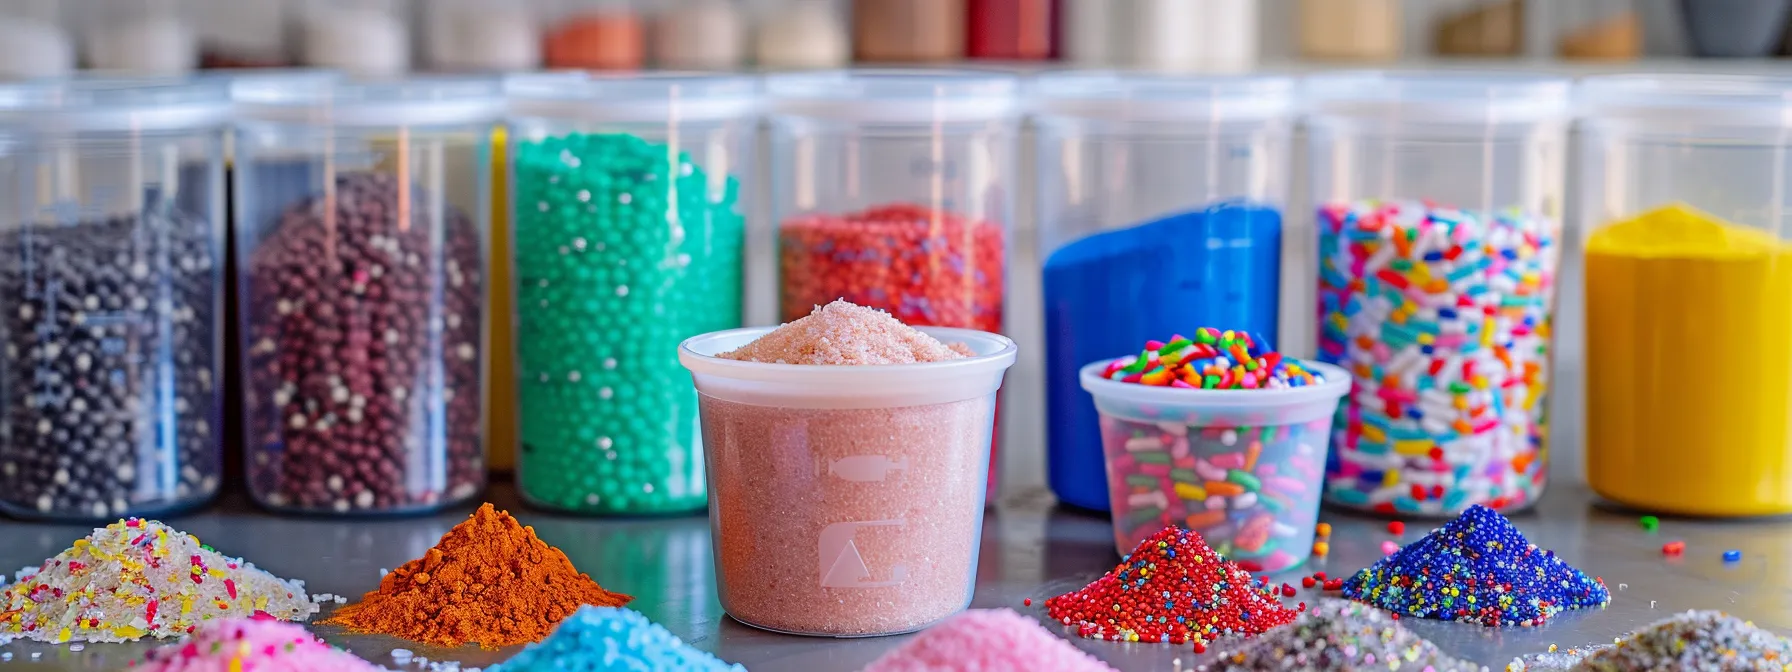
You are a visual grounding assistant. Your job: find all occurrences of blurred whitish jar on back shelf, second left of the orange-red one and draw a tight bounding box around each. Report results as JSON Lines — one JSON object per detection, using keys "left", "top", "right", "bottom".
{"left": 297, "top": 0, "right": 410, "bottom": 77}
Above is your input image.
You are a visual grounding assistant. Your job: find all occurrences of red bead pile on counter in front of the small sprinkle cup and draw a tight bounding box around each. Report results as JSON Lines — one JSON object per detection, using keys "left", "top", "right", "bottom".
{"left": 1045, "top": 527, "right": 1297, "bottom": 650}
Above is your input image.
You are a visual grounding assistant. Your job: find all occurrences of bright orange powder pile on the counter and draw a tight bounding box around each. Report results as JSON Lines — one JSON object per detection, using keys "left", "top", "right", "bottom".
{"left": 323, "top": 504, "right": 633, "bottom": 649}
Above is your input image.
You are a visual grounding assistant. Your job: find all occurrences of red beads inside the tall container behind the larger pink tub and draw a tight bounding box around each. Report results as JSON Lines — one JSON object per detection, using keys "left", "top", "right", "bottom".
{"left": 778, "top": 204, "right": 1005, "bottom": 332}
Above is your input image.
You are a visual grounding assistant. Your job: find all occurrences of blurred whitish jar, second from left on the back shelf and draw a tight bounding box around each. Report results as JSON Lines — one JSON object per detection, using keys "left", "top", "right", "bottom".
{"left": 79, "top": 0, "right": 199, "bottom": 75}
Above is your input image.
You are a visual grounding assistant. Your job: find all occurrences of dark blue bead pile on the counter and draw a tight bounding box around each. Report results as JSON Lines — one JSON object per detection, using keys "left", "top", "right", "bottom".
{"left": 1344, "top": 505, "right": 1611, "bottom": 627}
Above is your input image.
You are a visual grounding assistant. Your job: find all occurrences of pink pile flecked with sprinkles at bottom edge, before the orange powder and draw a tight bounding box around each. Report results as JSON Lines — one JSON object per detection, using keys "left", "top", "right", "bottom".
{"left": 131, "top": 618, "right": 383, "bottom": 672}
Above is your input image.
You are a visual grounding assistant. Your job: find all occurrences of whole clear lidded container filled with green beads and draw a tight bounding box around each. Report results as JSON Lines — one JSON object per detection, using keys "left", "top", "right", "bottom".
{"left": 509, "top": 73, "right": 758, "bottom": 514}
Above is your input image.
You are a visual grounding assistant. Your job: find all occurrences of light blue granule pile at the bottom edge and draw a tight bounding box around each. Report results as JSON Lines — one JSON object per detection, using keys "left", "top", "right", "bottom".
{"left": 487, "top": 606, "right": 747, "bottom": 672}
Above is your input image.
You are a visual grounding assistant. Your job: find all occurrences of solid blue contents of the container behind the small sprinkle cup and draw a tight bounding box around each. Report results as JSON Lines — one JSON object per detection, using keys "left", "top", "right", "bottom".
{"left": 1045, "top": 202, "right": 1281, "bottom": 511}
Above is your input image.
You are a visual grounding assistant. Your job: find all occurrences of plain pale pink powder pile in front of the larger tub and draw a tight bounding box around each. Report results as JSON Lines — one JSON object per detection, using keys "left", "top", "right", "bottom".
{"left": 866, "top": 609, "right": 1113, "bottom": 672}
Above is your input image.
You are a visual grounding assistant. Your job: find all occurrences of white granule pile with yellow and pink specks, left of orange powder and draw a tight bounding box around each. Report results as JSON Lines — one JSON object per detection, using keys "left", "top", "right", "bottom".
{"left": 0, "top": 518, "right": 317, "bottom": 643}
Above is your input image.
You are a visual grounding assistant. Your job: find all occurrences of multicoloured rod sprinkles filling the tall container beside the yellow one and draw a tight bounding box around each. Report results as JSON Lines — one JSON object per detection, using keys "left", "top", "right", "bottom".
{"left": 1319, "top": 201, "right": 1557, "bottom": 516}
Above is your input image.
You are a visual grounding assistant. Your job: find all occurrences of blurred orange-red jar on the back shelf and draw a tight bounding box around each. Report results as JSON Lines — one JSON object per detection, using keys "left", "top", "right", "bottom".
{"left": 541, "top": 0, "right": 647, "bottom": 70}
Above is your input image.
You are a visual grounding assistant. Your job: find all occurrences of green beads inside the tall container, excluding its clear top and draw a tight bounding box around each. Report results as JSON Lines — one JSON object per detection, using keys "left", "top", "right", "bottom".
{"left": 513, "top": 133, "right": 745, "bottom": 514}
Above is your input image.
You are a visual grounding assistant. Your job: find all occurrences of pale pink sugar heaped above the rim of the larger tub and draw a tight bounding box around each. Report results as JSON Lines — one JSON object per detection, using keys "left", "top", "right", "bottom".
{"left": 715, "top": 299, "right": 975, "bottom": 366}
